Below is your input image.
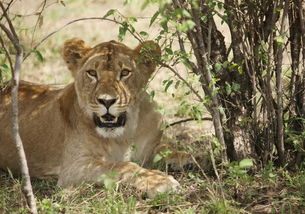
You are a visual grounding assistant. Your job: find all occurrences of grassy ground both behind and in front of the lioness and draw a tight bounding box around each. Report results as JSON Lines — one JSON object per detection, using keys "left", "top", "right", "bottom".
{"left": 0, "top": 0, "right": 305, "bottom": 213}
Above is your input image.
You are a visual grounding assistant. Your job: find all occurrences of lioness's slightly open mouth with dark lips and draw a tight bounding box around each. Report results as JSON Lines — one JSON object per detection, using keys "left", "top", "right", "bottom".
{"left": 93, "top": 112, "right": 127, "bottom": 128}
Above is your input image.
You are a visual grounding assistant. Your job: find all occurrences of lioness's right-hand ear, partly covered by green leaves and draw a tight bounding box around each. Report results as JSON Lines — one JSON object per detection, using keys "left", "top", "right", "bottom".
{"left": 134, "top": 41, "right": 161, "bottom": 77}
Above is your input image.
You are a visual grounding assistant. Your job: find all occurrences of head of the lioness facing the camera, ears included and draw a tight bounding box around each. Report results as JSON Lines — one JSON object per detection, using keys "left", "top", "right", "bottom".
{"left": 63, "top": 38, "right": 161, "bottom": 137}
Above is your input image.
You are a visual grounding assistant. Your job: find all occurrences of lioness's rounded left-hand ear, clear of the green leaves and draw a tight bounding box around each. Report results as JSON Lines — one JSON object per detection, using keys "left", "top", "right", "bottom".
{"left": 63, "top": 38, "right": 91, "bottom": 77}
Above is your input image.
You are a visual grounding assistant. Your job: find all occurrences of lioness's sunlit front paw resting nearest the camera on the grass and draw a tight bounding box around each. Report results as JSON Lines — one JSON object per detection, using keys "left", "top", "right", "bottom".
{"left": 136, "top": 170, "right": 180, "bottom": 197}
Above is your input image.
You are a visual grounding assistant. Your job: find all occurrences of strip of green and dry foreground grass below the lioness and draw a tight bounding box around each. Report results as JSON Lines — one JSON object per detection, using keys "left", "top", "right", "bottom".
{"left": 0, "top": 169, "right": 305, "bottom": 214}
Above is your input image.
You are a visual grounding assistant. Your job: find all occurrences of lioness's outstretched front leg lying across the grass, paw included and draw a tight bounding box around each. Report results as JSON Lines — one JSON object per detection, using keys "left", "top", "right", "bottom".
{"left": 58, "top": 160, "right": 179, "bottom": 196}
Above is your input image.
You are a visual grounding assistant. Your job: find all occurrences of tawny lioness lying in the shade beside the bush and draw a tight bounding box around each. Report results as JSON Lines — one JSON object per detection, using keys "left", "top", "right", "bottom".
{"left": 0, "top": 38, "right": 179, "bottom": 195}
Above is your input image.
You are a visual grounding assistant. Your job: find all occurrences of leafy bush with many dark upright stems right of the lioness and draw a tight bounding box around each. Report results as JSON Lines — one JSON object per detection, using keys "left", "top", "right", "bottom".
{"left": 119, "top": 0, "right": 305, "bottom": 166}
